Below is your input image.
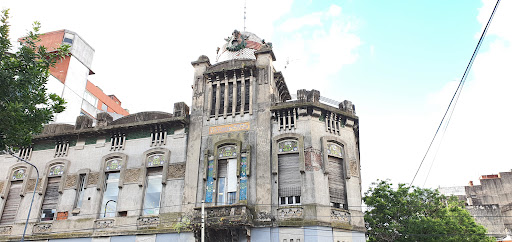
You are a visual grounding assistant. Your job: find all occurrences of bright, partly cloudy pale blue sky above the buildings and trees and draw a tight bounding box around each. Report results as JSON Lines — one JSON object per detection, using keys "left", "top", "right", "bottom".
{"left": 0, "top": 0, "right": 512, "bottom": 191}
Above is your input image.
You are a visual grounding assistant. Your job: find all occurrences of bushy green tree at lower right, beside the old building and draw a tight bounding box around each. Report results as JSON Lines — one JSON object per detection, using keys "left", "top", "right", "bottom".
{"left": 363, "top": 181, "right": 496, "bottom": 242}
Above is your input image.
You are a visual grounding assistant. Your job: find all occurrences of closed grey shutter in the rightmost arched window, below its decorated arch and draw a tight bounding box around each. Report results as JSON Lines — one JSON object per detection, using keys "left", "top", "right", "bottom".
{"left": 328, "top": 156, "right": 347, "bottom": 204}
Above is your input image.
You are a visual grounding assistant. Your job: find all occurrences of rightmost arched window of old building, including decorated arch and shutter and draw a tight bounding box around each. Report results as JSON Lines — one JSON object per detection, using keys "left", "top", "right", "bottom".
{"left": 326, "top": 142, "right": 347, "bottom": 209}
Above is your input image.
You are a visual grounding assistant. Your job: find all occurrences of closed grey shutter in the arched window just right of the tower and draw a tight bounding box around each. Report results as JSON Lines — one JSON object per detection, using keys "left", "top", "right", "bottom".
{"left": 278, "top": 153, "right": 302, "bottom": 197}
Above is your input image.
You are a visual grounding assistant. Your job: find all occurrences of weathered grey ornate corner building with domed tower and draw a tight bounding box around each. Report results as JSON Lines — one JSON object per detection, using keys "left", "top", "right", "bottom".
{"left": 0, "top": 31, "right": 365, "bottom": 242}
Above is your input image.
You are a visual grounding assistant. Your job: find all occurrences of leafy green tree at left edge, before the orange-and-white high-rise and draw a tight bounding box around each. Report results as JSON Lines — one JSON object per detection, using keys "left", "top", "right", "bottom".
{"left": 0, "top": 9, "right": 69, "bottom": 150}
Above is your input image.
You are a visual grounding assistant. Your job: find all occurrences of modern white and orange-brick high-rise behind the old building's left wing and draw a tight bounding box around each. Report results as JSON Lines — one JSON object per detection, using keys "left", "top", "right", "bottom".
{"left": 38, "top": 29, "right": 128, "bottom": 124}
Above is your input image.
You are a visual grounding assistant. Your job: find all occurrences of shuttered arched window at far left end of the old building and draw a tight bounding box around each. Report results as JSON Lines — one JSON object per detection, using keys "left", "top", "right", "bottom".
{"left": 0, "top": 167, "right": 27, "bottom": 225}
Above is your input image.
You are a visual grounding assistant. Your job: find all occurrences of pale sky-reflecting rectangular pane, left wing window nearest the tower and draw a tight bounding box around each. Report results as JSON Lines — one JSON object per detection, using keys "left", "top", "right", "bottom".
{"left": 143, "top": 167, "right": 162, "bottom": 215}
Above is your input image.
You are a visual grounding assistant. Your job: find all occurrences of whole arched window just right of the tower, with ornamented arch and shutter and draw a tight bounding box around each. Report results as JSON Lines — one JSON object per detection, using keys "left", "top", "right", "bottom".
{"left": 277, "top": 139, "right": 302, "bottom": 205}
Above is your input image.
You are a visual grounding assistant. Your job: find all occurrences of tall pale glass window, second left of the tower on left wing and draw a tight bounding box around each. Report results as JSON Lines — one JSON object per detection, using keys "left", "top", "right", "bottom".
{"left": 100, "top": 172, "right": 120, "bottom": 218}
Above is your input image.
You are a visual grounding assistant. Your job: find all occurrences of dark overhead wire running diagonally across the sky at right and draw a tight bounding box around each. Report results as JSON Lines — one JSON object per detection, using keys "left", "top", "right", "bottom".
{"left": 409, "top": 0, "right": 501, "bottom": 187}
